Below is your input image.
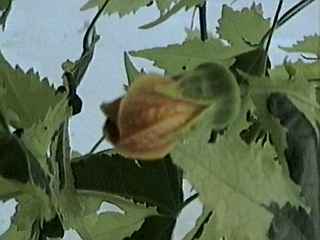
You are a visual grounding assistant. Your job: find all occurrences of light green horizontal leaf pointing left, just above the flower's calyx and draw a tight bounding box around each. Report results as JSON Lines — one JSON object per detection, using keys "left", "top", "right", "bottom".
{"left": 130, "top": 39, "right": 239, "bottom": 75}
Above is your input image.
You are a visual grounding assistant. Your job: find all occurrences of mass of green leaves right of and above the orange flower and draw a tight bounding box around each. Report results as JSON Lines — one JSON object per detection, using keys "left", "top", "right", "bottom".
{"left": 125, "top": 2, "right": 320, "bottom": 239}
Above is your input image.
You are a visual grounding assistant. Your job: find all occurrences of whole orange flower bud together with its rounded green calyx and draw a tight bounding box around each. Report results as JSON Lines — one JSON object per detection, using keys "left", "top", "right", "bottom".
{"left": 101, "top": 64, "right": 240, "bottom": 160}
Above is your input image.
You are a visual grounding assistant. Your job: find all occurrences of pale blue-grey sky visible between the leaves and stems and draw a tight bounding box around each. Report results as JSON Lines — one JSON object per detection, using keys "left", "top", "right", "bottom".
{"left": 0, "top": 0, "right": 320, "bottom": 240}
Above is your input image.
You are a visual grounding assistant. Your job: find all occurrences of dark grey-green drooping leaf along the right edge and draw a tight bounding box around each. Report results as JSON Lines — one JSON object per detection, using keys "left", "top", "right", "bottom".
{"left": 270, "top": 95, "right": 320, "bottom": 237}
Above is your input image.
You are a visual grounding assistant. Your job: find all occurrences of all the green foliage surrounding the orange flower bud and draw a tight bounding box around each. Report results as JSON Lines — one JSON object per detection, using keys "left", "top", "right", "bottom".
{"left": 0, "top": 0, "right": 320, "bottom": 240}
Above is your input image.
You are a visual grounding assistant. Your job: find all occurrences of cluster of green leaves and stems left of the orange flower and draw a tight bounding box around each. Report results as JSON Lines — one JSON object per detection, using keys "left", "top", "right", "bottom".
{"left": 0, "top": 2, "right": 160, "bottom": 240}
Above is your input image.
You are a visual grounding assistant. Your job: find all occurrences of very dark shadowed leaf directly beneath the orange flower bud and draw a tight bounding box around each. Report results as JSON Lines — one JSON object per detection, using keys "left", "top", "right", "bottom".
{"left": 72, "top": 152, "right": 183, "bottom": 240}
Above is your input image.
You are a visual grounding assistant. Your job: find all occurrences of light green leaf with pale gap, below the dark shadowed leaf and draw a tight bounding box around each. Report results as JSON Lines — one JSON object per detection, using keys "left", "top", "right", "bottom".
{"left": 62, "top": 191, "right": 158, "bottom": 240}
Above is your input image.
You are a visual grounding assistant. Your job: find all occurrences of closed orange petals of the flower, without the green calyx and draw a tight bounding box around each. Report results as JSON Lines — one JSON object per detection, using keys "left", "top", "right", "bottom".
{"left": 101, "top": 75, "right": 205, "bottom": 160}
